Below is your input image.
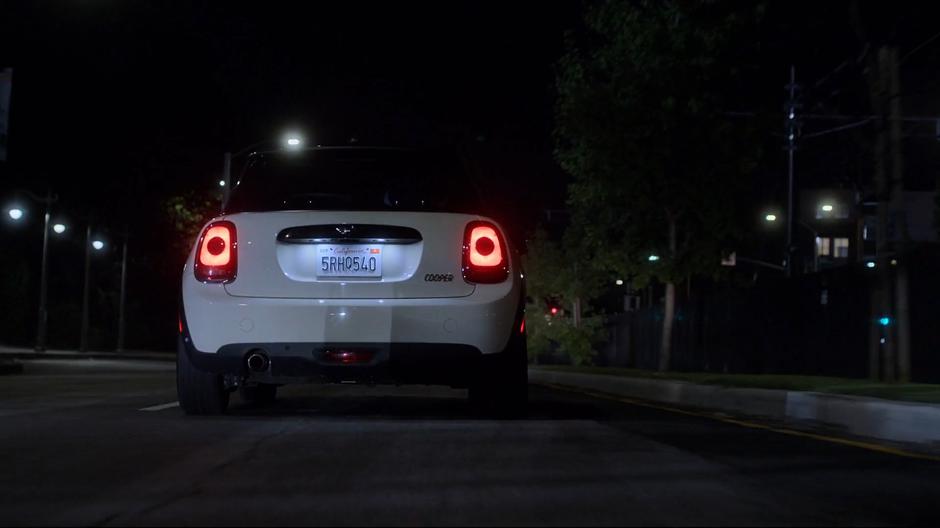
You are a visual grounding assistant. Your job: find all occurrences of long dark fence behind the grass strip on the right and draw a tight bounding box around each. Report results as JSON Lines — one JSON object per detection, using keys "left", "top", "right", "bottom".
{"left": 597, "top": 246, "right": 940, "bottom": 382}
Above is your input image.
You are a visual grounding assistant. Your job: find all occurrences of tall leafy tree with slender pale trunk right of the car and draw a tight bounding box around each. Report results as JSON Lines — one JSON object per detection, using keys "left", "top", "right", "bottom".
{"left": 555, "top": 1, "right": 763, "bottom": 370}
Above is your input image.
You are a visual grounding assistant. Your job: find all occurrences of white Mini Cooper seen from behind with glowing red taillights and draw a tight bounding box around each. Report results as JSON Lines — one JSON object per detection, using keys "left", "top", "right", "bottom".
{"left": 177, "top": 148, "right": 526, "bottom": 414}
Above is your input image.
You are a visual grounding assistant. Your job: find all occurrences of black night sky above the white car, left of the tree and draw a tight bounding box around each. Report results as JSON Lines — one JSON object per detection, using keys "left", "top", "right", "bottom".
{"left": 0, "top": 1, "right": 580, "bottom": 224}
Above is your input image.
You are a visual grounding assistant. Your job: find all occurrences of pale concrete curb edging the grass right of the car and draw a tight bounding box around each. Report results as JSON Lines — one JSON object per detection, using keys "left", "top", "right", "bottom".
{"left": 529, "top": 368, "right": 940, "bottom": 448}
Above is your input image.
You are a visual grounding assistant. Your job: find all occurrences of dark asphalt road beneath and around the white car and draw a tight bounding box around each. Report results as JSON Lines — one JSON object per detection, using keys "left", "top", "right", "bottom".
{"left": 0, "top": 360, "right": 940, "bottom": 525}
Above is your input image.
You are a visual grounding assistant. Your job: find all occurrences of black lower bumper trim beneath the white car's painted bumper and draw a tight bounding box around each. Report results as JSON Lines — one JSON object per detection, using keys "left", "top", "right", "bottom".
{"left": 178, "top": 333, "right": 484, "bottom": 387}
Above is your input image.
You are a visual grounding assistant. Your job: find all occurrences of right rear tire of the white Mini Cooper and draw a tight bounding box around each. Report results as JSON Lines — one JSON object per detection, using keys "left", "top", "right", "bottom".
{"left": 467, "top": 336, "right": 529, "bottom": 418}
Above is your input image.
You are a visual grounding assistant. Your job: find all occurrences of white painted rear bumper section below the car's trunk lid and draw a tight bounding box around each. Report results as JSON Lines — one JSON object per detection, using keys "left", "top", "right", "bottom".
{"left": 181, "top": 272, "right": 522, "bottom": 354}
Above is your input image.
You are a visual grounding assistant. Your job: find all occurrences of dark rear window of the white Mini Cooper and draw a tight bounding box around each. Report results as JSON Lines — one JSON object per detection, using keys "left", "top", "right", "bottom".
{"left": 226, "top": 148, "right": 484, "bottom": 214}
